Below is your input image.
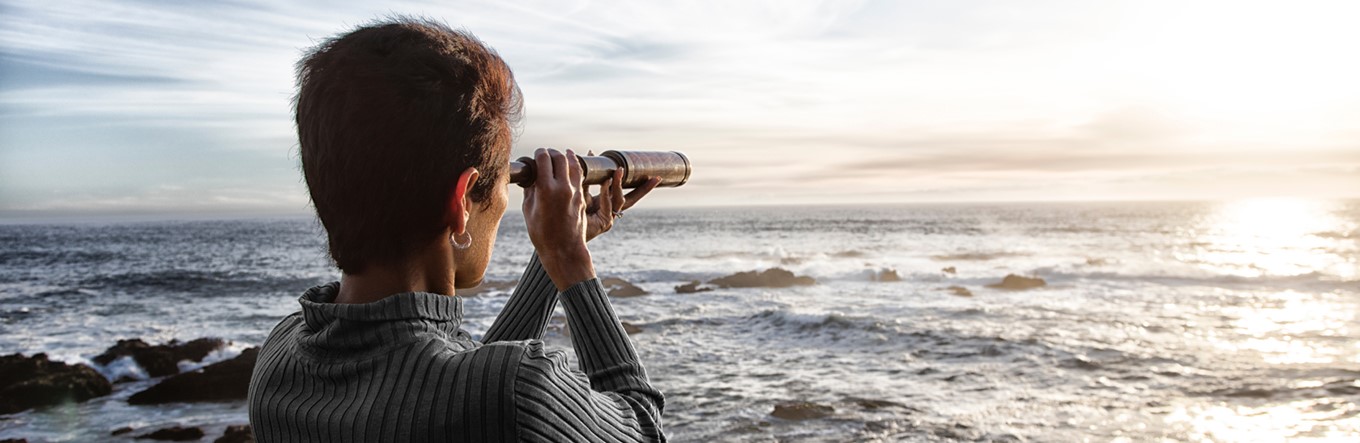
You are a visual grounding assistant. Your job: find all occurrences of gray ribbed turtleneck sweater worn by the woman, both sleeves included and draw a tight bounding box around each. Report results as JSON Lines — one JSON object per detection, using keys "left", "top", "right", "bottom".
{"left": 250, "top": 255, "right": 665, "bottom": 442}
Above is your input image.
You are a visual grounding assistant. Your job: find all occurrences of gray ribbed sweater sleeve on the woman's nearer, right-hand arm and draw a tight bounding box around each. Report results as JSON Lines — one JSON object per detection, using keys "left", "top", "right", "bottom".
{"left": 515, "top": 279, "right": 666, "bottom": 442}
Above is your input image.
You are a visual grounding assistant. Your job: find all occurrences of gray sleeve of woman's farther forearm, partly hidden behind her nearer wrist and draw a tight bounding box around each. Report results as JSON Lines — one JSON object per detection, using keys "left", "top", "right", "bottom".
{"left": 481, "top": 253, "right": 558, "bottom": 342}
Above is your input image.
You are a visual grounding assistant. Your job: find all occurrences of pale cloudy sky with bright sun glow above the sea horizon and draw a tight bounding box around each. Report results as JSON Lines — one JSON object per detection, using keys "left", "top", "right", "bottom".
{"left": 0, "top": 0, "right": 1360, "bottom": 217}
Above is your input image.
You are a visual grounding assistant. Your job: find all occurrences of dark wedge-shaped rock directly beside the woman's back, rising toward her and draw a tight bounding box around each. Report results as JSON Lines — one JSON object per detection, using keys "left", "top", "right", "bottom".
{"left": 128, "top": 348, "right": 260, "bottom": 405}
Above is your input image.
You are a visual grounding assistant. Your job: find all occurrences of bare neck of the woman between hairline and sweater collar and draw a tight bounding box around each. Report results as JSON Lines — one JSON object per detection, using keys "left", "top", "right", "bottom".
{"left": 335, "top": 245, "right": 456, "bottom": 303}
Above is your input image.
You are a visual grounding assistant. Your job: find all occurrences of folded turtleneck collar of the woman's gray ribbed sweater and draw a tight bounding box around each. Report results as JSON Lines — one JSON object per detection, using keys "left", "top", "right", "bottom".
{"left": 298, "top": 281, "right": 475, "bottom": 359}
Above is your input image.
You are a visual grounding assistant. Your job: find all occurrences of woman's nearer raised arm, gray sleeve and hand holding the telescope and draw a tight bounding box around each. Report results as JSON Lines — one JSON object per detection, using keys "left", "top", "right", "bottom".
{"left": 515, "top": 149, "right": 665, "bottom": 442}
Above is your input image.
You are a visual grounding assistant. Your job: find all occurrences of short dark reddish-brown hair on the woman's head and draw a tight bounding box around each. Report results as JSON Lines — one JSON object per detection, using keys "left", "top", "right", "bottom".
{"left": 294, "top": 16, "right": 521, "bottom": 274}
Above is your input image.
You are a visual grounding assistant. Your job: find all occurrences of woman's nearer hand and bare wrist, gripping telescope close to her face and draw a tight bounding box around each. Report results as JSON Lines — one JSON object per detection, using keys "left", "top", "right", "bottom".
{"left": 524, "top": 148, "right": 594, "bottom": 291}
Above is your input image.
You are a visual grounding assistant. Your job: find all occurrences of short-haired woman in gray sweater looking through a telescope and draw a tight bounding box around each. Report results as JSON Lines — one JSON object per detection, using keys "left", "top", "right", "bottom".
{"left": 249, "top": 18, "right": 665, "bottom": 442}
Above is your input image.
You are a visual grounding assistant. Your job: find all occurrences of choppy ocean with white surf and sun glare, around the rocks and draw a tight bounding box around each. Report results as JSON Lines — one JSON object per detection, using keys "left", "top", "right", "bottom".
{"left": 0, "top": 200, "right": 1360, "bottom": 442}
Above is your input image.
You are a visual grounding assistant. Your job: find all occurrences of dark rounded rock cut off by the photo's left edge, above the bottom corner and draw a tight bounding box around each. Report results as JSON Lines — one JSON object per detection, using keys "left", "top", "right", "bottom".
{"left": 0, "top": 353, "right": 113, "bottom": 414}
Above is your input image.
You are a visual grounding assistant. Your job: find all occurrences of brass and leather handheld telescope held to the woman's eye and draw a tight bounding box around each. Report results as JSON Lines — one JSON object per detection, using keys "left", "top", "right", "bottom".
{"left": 510, "top": 151, "right": 692, "bottom": 188}
